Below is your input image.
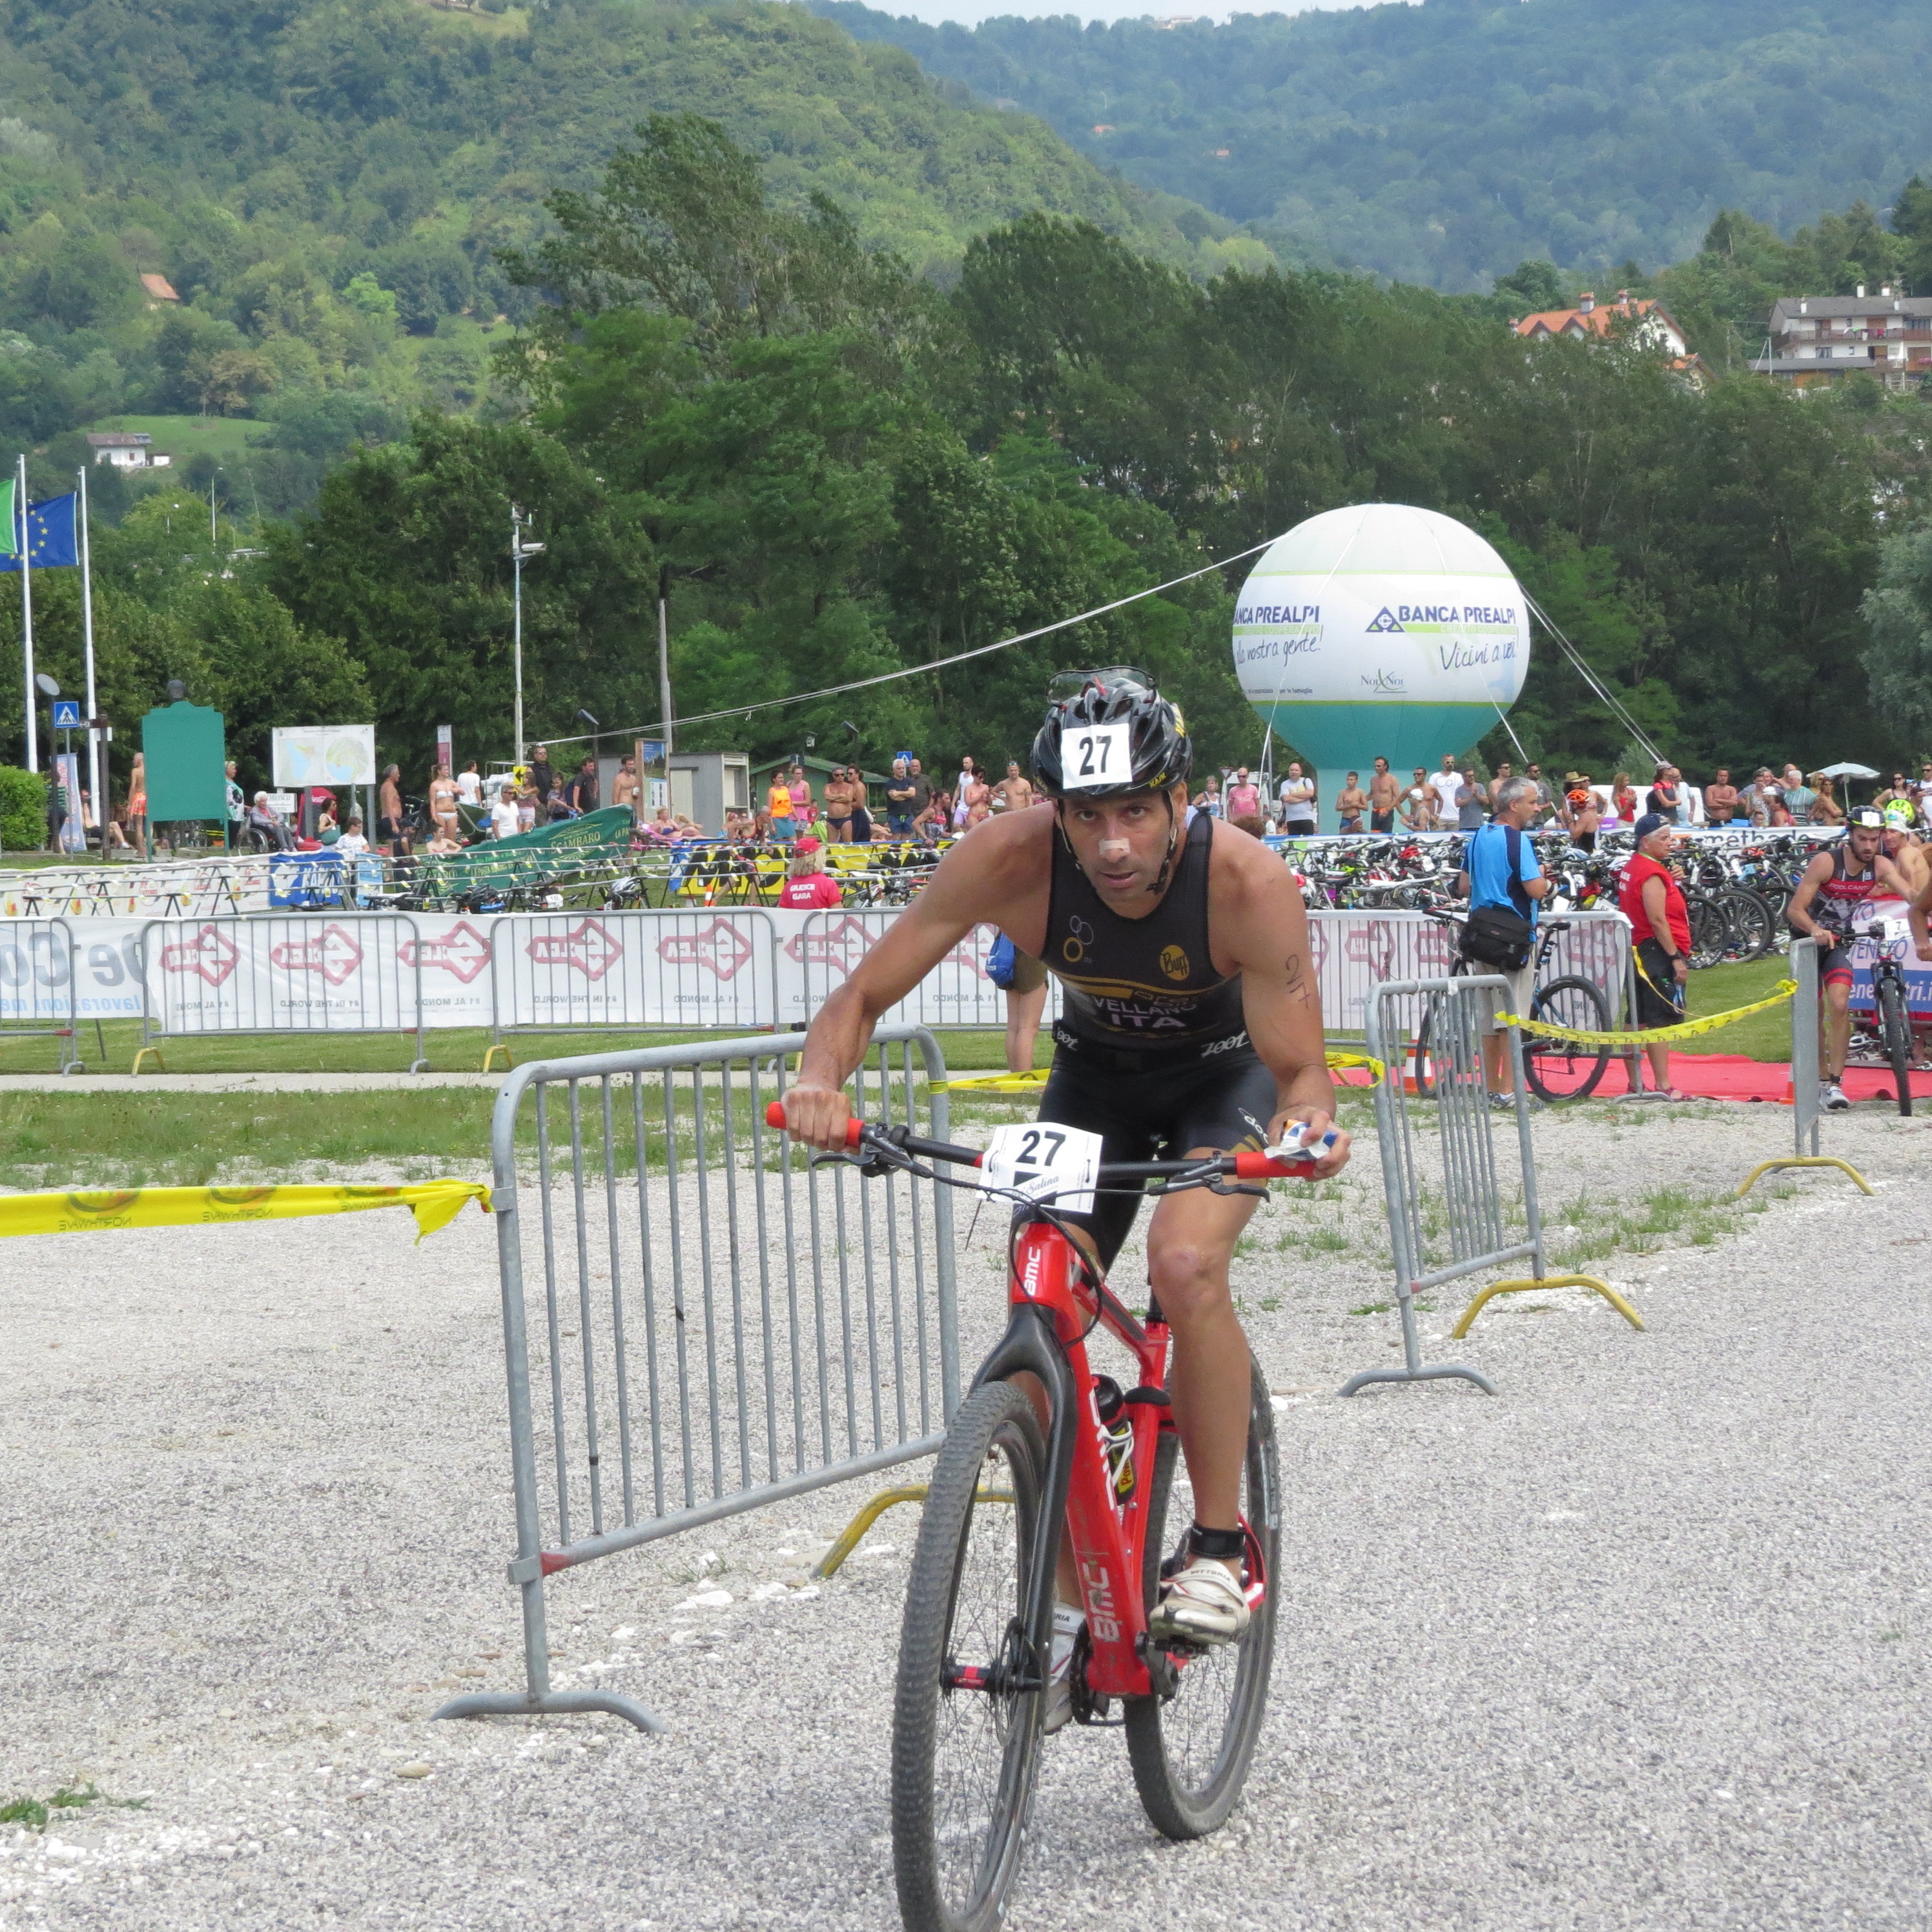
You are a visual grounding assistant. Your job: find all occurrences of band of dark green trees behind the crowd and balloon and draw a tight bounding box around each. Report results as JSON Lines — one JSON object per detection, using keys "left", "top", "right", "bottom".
{"left": 0, "top": 116, "right": 1932, "bottom": 807}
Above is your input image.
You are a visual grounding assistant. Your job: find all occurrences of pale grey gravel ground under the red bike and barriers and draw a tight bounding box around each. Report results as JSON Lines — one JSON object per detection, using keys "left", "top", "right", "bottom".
{"left": 0, "top": 1105, "right": 1932, "bottom": 1932}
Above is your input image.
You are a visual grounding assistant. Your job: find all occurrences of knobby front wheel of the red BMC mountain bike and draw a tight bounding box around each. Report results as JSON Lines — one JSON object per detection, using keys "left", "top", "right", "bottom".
{"left": 892, "top": 1381, "right": 1047, "bottom": 1932}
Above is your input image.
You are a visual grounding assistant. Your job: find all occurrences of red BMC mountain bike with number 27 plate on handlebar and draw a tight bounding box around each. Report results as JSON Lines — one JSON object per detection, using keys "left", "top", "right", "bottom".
{"left": 767, "top": 1101, "right": 1314, "bottom": 1932}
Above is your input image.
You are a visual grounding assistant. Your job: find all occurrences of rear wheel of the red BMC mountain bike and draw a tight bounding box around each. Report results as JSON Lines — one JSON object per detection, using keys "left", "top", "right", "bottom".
{"left": 1124, "top": 1362, "right": 1281, "bottom": 1839}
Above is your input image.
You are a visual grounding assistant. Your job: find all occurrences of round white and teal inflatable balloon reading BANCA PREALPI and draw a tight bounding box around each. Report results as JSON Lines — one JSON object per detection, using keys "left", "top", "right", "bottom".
{"left": 1235, "top": 502, "right": 1530, "bottom": 792}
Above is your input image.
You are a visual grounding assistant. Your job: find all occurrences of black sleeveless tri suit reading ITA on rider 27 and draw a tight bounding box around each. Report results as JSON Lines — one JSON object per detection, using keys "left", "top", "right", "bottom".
{"left": 1040, "top": 812, "right": 1275, "bottom": 1266}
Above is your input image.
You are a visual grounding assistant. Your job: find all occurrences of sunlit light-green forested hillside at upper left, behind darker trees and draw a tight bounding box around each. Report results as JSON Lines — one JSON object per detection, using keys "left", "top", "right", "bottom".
{"left": 0, "top": 0, "right": 1266, "bottom": 514}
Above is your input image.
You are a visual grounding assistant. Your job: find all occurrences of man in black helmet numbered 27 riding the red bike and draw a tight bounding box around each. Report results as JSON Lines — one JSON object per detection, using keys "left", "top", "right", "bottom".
{"left": 785, "top": 668, "right": 1348, "bottom": 1667}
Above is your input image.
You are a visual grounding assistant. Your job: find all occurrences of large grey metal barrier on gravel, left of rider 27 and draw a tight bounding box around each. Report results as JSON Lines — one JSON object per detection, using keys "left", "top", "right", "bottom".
{"left": 437, "top": 1028, "right": 958, "bottom": 1729}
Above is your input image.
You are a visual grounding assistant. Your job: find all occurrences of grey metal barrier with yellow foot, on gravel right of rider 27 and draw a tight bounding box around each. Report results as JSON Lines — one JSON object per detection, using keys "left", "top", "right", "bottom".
{"left": 1341, "top": 974, "right": 1642, "bottom": 1395}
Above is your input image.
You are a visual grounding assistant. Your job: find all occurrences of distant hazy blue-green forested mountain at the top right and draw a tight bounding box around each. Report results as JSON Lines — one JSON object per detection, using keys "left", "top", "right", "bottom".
{"left": 814, "top": 0, "right": 1932, "bottom": 292}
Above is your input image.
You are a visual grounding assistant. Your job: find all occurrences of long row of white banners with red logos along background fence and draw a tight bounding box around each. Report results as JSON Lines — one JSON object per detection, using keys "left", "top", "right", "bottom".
{"left": 0, "top": 906, "right": 1629, "bottom": 1036}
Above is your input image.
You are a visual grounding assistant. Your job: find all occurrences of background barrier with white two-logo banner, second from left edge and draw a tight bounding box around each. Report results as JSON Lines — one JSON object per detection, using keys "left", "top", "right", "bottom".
{"left": 133, "top": 912, "right": 429, "bottom": 1073}
